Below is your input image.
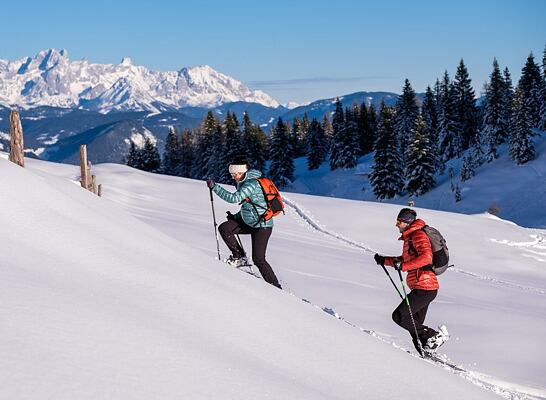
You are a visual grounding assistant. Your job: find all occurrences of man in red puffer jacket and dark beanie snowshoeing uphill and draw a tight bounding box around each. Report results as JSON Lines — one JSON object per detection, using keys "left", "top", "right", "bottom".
{"left": 374, "top": 208, "right": 449, "bottom": 354}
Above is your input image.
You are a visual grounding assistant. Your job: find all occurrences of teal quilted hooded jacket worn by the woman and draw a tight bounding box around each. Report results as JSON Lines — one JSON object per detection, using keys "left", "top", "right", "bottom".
{"left": 212, "top": 169, "right": 273, "bottom": 228}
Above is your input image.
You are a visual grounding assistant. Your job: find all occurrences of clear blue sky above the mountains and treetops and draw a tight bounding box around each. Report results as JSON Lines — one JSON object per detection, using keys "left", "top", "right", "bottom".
{"left": 0, "top": 0, "right": 546, "bottom": 103}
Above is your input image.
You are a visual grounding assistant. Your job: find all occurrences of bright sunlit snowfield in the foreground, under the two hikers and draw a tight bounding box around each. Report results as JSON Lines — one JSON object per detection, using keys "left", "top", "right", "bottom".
{"left": 0, "top": 153, "right": 546, "bottom": 399}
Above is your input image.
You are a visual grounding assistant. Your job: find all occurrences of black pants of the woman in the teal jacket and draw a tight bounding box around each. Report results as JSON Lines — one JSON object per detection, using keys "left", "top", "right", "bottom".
{"left": 218, "top": 219, "right": 281, "bottom": 289}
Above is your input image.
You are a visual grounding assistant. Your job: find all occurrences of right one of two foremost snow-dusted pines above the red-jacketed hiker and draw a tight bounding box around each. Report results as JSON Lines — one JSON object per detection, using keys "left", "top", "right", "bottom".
{"left": 406, "top": 115, "right": 436, "bottom": 196}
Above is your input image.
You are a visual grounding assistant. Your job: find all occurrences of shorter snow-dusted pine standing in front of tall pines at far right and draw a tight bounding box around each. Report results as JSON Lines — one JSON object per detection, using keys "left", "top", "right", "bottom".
{"left": 509, "top": 85, "right": 535, "bottom": 165}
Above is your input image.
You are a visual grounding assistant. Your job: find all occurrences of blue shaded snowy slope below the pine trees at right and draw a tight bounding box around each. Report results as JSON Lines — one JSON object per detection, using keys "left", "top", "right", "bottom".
{"left": 290, "top": 132, "right": 546, "bottom": 228}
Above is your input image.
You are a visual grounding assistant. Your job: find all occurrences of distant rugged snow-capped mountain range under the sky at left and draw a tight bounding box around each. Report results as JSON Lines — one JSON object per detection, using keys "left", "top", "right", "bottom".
{"left": 0, "top": 49, "right": 279, "bottom": 113}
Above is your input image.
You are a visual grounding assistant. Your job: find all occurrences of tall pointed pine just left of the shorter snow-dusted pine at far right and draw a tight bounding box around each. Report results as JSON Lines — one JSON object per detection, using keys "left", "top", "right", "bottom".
{"left": 480, "top": 59, "right": 508, "bottom": 162}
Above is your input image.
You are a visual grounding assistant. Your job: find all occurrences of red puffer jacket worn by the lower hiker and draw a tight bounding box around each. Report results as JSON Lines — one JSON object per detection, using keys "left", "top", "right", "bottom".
{"left": 385, "top": 219, "right": 440, "bottom": 290}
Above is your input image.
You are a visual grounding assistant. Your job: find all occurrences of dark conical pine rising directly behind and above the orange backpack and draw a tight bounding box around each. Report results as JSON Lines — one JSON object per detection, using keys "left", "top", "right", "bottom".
{"left": 269, "top": 117, "right": 295, "bottom": 188}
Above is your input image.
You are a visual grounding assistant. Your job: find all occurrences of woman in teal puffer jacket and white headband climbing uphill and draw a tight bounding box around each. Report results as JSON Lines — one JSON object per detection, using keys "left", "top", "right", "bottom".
{"left": 207, "top": 156, "right": 281, "bottom": 289}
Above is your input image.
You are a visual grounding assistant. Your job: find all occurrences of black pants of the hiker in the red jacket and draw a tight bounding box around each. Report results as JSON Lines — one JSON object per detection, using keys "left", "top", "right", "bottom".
{"left": 392, "top": 289, "right": 438, "bottom": 352}
